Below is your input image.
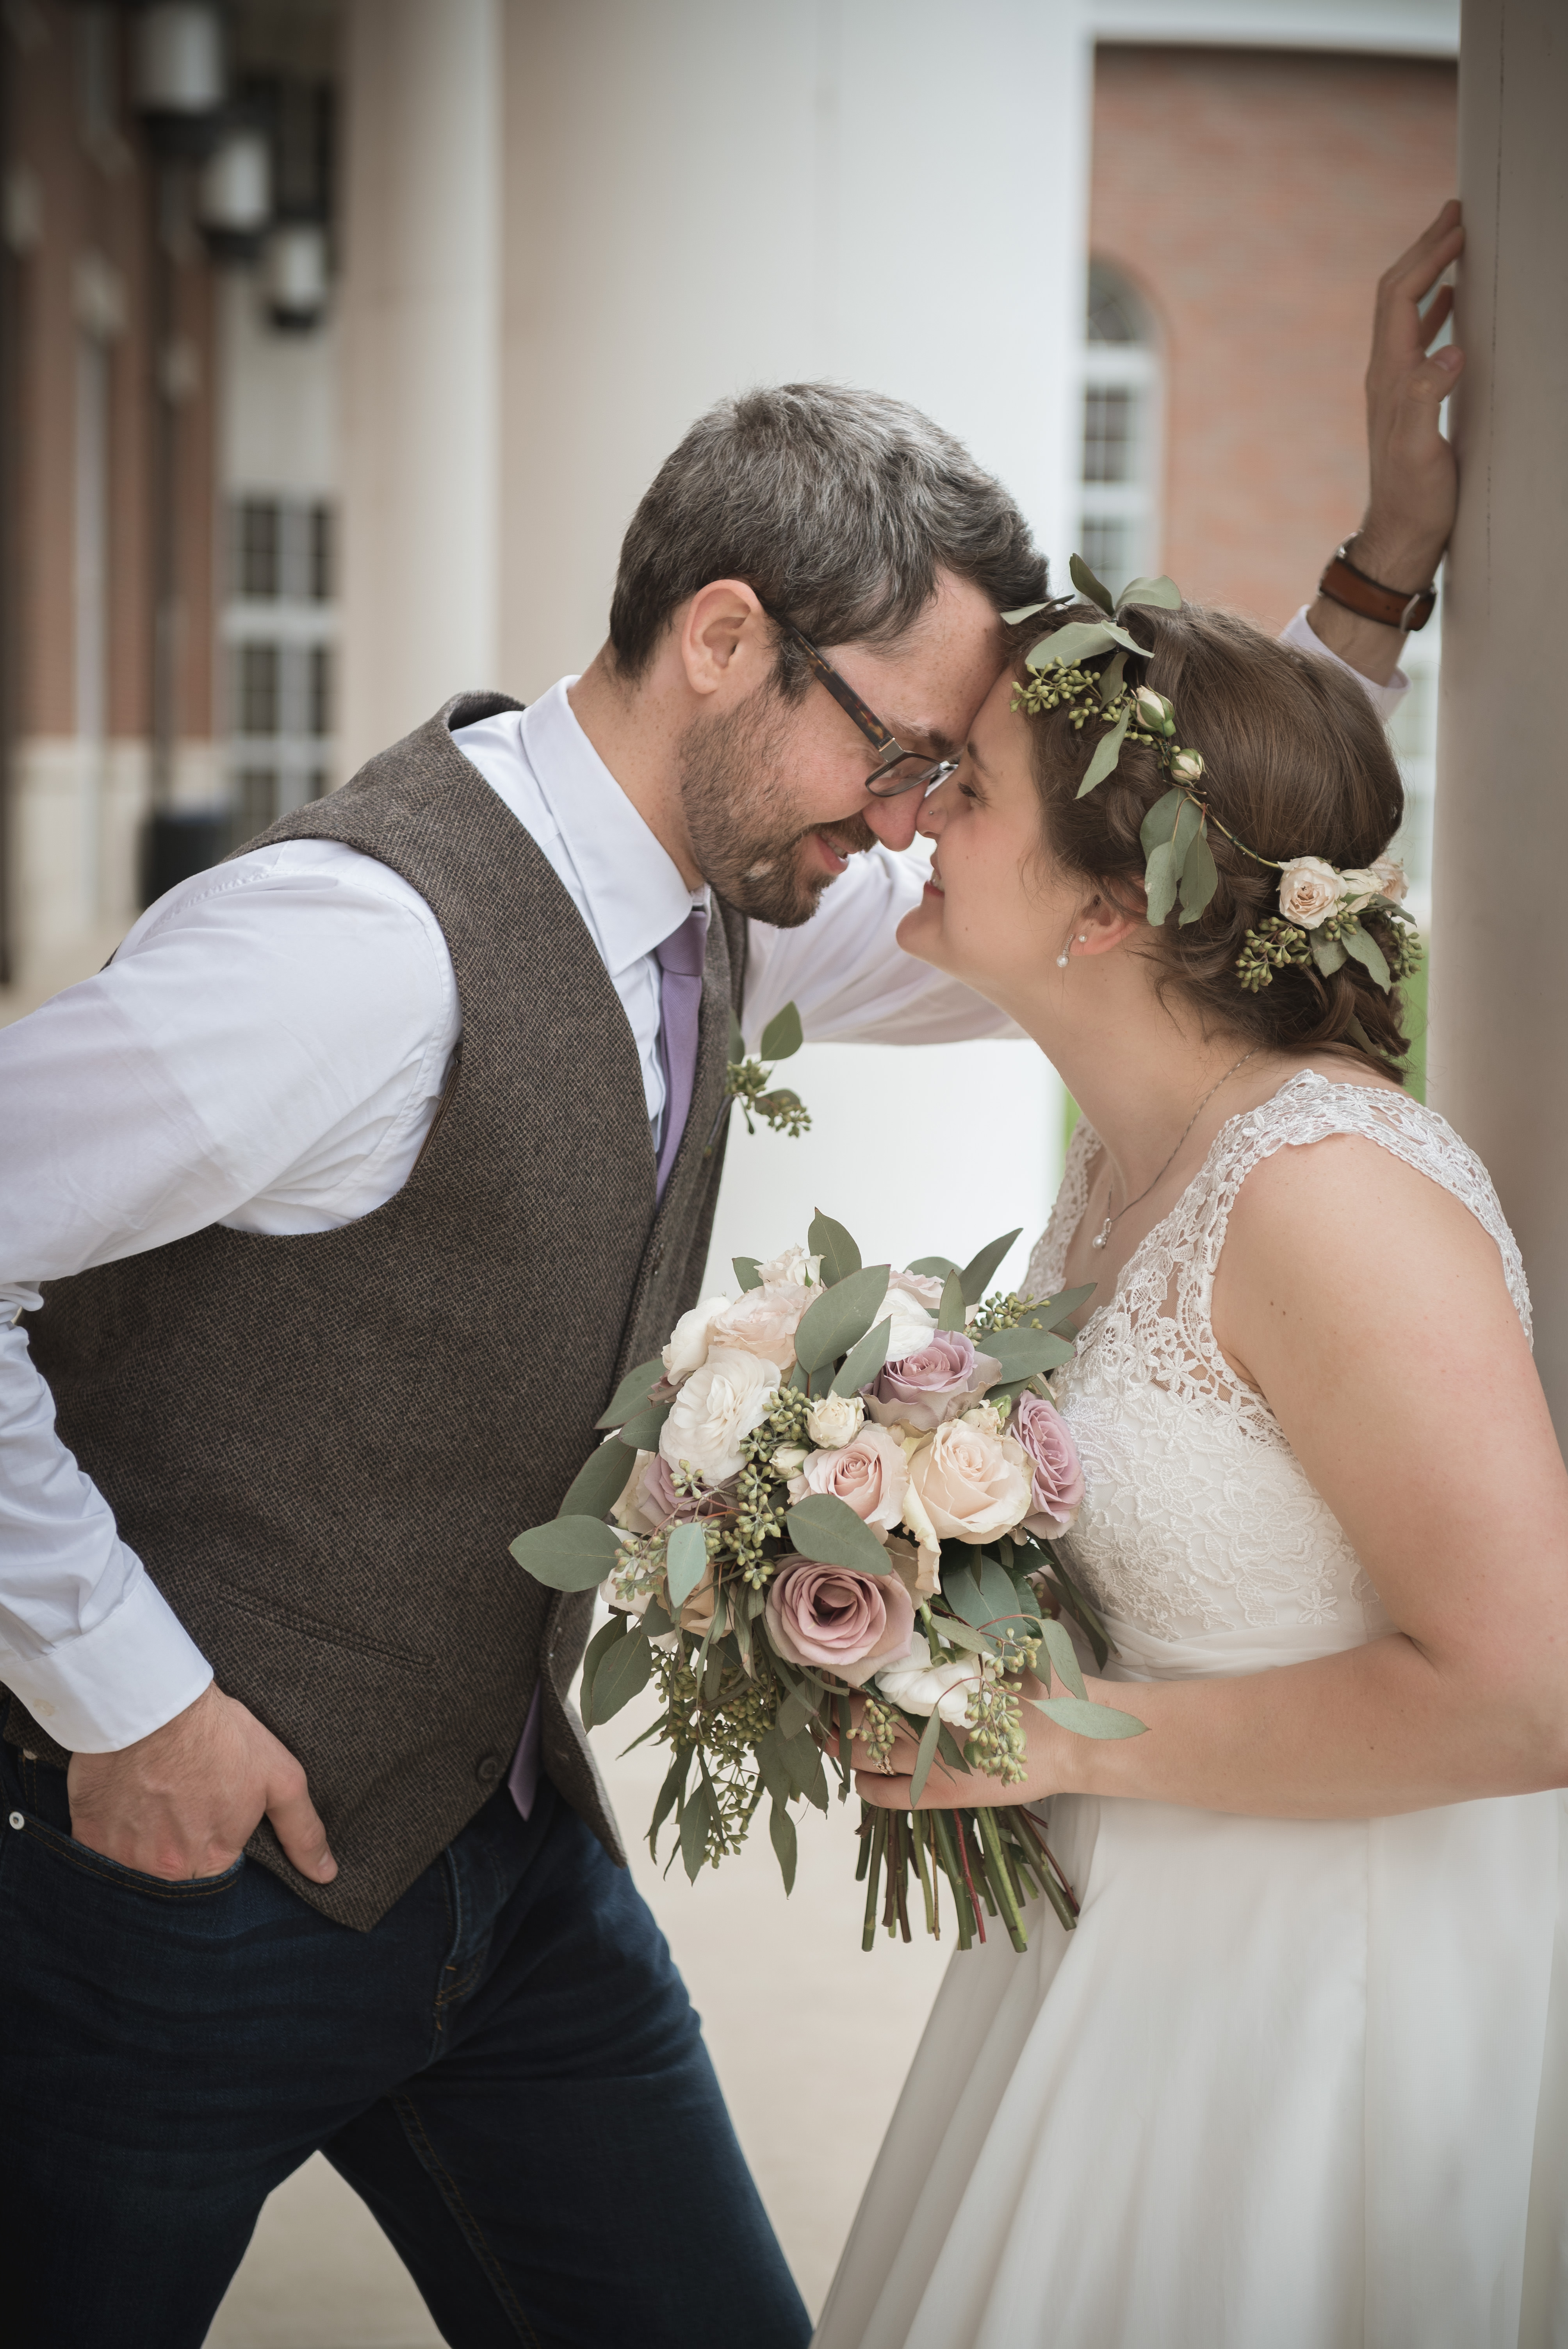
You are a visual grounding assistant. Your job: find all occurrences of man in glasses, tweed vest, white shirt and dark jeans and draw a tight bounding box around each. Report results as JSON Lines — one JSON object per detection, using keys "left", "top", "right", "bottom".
{"left": 0, "top": 221, "right": 1441, "bottom": 2349}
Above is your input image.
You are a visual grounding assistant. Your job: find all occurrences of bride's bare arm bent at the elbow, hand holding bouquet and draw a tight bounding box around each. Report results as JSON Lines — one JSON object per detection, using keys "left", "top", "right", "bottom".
{"left": 859, "top": 1137, "right": 1568, "bottom": 1818}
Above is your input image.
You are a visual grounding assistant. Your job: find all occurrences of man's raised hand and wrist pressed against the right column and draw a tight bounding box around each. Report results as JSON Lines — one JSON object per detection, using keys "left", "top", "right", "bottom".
{"left": 1308, "top": 202, "right": 1465, "bottom": 684}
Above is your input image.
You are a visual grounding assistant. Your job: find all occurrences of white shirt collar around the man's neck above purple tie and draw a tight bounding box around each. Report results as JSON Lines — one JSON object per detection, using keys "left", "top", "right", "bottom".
{"left": 521, "top": 677, "right": 709, "bottom": 977}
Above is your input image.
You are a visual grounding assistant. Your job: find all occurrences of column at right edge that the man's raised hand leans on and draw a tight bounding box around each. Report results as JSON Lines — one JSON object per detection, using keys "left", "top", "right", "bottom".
{"left": 1429, "top": 0, "right": 1568, "bottom": 1435}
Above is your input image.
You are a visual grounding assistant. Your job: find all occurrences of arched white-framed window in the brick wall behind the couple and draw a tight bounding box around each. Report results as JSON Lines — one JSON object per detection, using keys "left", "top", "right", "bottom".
{"left": 1077, "top": 261, "right": 1162, "bottom": 590}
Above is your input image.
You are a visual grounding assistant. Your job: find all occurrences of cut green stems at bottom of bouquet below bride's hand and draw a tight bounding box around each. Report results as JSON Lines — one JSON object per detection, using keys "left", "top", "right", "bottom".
{"left": 854, "top": 1802, "right": 1077, "bottom": 1950}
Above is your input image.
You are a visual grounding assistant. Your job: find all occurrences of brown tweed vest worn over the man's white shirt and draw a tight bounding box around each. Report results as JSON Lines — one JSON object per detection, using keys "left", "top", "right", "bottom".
{"left": 7, "top": 693, "right": 744, "bottom": 1928}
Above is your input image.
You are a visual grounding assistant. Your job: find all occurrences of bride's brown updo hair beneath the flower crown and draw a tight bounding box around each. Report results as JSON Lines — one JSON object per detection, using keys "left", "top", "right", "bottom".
{"left": 1012, "top": 604, "right": 1408, "bottom": 1076}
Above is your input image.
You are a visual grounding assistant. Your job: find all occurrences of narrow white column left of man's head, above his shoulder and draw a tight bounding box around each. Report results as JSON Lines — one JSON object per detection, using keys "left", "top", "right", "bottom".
{"left": 343, "top": 0, "right": 502, "bottom": 773}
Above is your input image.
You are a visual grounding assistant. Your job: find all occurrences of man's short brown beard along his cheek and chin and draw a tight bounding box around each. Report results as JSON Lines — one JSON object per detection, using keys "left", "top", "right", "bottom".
{"left": 681, "top": 688, "right": 875, "bottom": 930}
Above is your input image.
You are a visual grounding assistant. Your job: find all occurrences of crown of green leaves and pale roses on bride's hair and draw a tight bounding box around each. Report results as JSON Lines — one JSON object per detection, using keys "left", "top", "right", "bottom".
{"left": 1002, "top": 554, "right": 1420, "bottom": 994}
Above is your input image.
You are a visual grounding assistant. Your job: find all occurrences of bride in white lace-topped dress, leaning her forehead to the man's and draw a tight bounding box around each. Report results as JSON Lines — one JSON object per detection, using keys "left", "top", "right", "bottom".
{"left": 817, "top": 568, "right": 1568, "bottom": 2349}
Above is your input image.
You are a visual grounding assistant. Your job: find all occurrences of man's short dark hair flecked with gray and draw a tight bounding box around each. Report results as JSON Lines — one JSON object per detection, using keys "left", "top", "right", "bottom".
{"left": 610, "top": 383, "right": 1047, "bottom": 693}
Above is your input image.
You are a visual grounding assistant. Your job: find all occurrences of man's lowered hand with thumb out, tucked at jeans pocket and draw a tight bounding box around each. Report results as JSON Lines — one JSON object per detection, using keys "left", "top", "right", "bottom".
{"left": 66, "top": 1684, "right": 338, "bottom": 1884}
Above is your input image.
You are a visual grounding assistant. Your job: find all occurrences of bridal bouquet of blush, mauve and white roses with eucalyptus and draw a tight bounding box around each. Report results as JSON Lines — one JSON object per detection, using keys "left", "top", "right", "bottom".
{"left": 512, "top": 1214, "right": 1141, "bottom": 1950}
